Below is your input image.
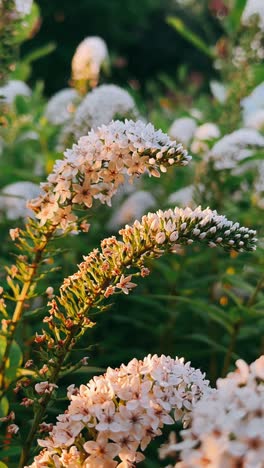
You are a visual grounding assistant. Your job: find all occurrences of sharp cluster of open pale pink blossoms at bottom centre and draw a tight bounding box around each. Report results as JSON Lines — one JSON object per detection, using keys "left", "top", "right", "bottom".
{"left": 27, "top": 355, "right": 210, "bottom": 468}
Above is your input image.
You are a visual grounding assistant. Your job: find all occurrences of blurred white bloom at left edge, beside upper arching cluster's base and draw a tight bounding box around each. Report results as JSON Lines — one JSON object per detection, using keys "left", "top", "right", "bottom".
{"left": 0, "top": 182, "right": 40, "bottom": 219}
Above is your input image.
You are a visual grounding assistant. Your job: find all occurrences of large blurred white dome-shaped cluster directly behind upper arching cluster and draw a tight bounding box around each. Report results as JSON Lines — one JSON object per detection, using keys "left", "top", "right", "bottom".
{"left": 73, "top": 85, "right": 138, "bottom": 138}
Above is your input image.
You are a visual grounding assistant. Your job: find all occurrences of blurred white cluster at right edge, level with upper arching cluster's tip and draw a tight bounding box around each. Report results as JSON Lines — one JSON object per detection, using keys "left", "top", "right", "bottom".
{"left": 207, "top": 128, "right": 264, "bottom": 170}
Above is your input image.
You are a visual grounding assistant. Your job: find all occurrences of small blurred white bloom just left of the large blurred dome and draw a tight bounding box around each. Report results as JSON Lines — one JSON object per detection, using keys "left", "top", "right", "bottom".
{"left": 45, "top": 88, "right": 80, "bottom": 125}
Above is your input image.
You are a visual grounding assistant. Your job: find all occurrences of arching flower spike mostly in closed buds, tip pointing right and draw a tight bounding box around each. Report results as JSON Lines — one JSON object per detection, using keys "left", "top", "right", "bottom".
{"left": 50, "top": 207, "right": 257, "bottom": 329}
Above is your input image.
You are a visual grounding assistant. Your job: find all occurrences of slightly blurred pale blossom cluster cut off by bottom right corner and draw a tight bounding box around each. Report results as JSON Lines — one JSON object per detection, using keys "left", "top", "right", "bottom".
{"left": 162, "top": 356, "right": 264, "bottom": 468}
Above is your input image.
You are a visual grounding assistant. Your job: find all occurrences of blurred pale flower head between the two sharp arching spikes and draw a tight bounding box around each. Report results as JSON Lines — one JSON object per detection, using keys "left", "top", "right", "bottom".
{"left": 108, "top": 190, "right": 156, "bottom": 230}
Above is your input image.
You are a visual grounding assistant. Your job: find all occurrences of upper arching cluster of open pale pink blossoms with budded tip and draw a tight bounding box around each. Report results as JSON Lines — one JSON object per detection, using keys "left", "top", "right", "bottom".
{"left": 28, "top": 120, "right": 191, "bottom": 230}
